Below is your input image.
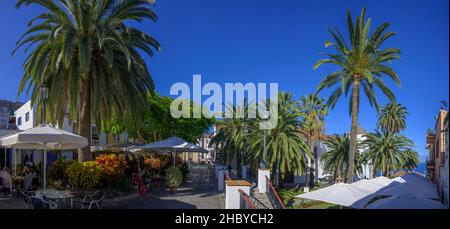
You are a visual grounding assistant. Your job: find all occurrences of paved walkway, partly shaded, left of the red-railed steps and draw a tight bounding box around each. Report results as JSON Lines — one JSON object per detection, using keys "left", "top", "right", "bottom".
{"left": 105, "top": 166, "right": 225, "bottom": 209}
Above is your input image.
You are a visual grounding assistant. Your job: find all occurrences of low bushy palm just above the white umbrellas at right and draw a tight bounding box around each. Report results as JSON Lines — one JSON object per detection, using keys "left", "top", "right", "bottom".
{"left": 363, "top": 130, "right": 417, "bottom": 176}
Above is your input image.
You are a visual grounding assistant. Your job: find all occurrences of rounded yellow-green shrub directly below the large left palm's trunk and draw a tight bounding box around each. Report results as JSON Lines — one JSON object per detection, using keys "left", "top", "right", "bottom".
{"left": 67, "top": 161, "right": 102, "bottom": 191}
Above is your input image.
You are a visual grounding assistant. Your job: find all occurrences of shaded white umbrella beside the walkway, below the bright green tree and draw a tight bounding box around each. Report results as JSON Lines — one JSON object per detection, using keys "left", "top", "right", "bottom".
{"left": 133, "top": 136, "right": 208, "bottom": 164}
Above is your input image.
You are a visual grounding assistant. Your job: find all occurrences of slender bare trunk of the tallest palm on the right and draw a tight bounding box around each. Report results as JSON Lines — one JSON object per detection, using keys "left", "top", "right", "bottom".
{"left": 346, "top": 78, "right": 360, "bottom": 183}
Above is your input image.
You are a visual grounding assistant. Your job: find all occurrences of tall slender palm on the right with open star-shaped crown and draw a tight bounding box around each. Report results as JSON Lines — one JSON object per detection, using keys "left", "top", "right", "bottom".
{"left": 313, "top": 8, "right": 400, "bottom": 183}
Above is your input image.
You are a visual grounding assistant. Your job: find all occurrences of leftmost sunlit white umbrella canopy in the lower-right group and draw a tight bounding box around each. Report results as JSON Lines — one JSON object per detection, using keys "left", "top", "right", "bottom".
{"left": 295, "top": 183, "right": 370, "bottom": 207}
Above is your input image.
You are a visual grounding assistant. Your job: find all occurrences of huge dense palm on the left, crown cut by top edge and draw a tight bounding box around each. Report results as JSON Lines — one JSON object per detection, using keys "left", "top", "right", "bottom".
{"left": 13, "top": 0, "right": 160, "bottom": 161}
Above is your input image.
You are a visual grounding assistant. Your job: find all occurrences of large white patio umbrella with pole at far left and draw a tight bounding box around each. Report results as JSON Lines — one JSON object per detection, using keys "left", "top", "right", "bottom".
{"left": 0, "top": 126, "right": 89, "bottom": 189}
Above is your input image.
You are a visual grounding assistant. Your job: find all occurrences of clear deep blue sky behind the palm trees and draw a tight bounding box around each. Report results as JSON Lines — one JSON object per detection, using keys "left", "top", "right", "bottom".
{"left": 0, "top": 0, "right": 449, "bottom": 160}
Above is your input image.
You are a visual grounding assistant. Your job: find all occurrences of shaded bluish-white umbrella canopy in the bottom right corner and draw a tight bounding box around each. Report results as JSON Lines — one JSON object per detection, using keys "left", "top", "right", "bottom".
{"left": 366, "top": 195, "right": 446, "bottom": 209}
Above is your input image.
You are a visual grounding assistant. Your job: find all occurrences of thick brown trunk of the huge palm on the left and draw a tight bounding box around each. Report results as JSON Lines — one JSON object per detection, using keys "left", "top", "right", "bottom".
{"left": 78, "top": 77, "right": 92, "bottom": 161}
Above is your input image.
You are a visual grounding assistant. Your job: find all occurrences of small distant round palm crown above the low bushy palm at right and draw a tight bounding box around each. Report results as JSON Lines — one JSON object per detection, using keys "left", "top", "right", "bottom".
{"left": 377, "top": 102, "right": 408, "bottom": 133}
